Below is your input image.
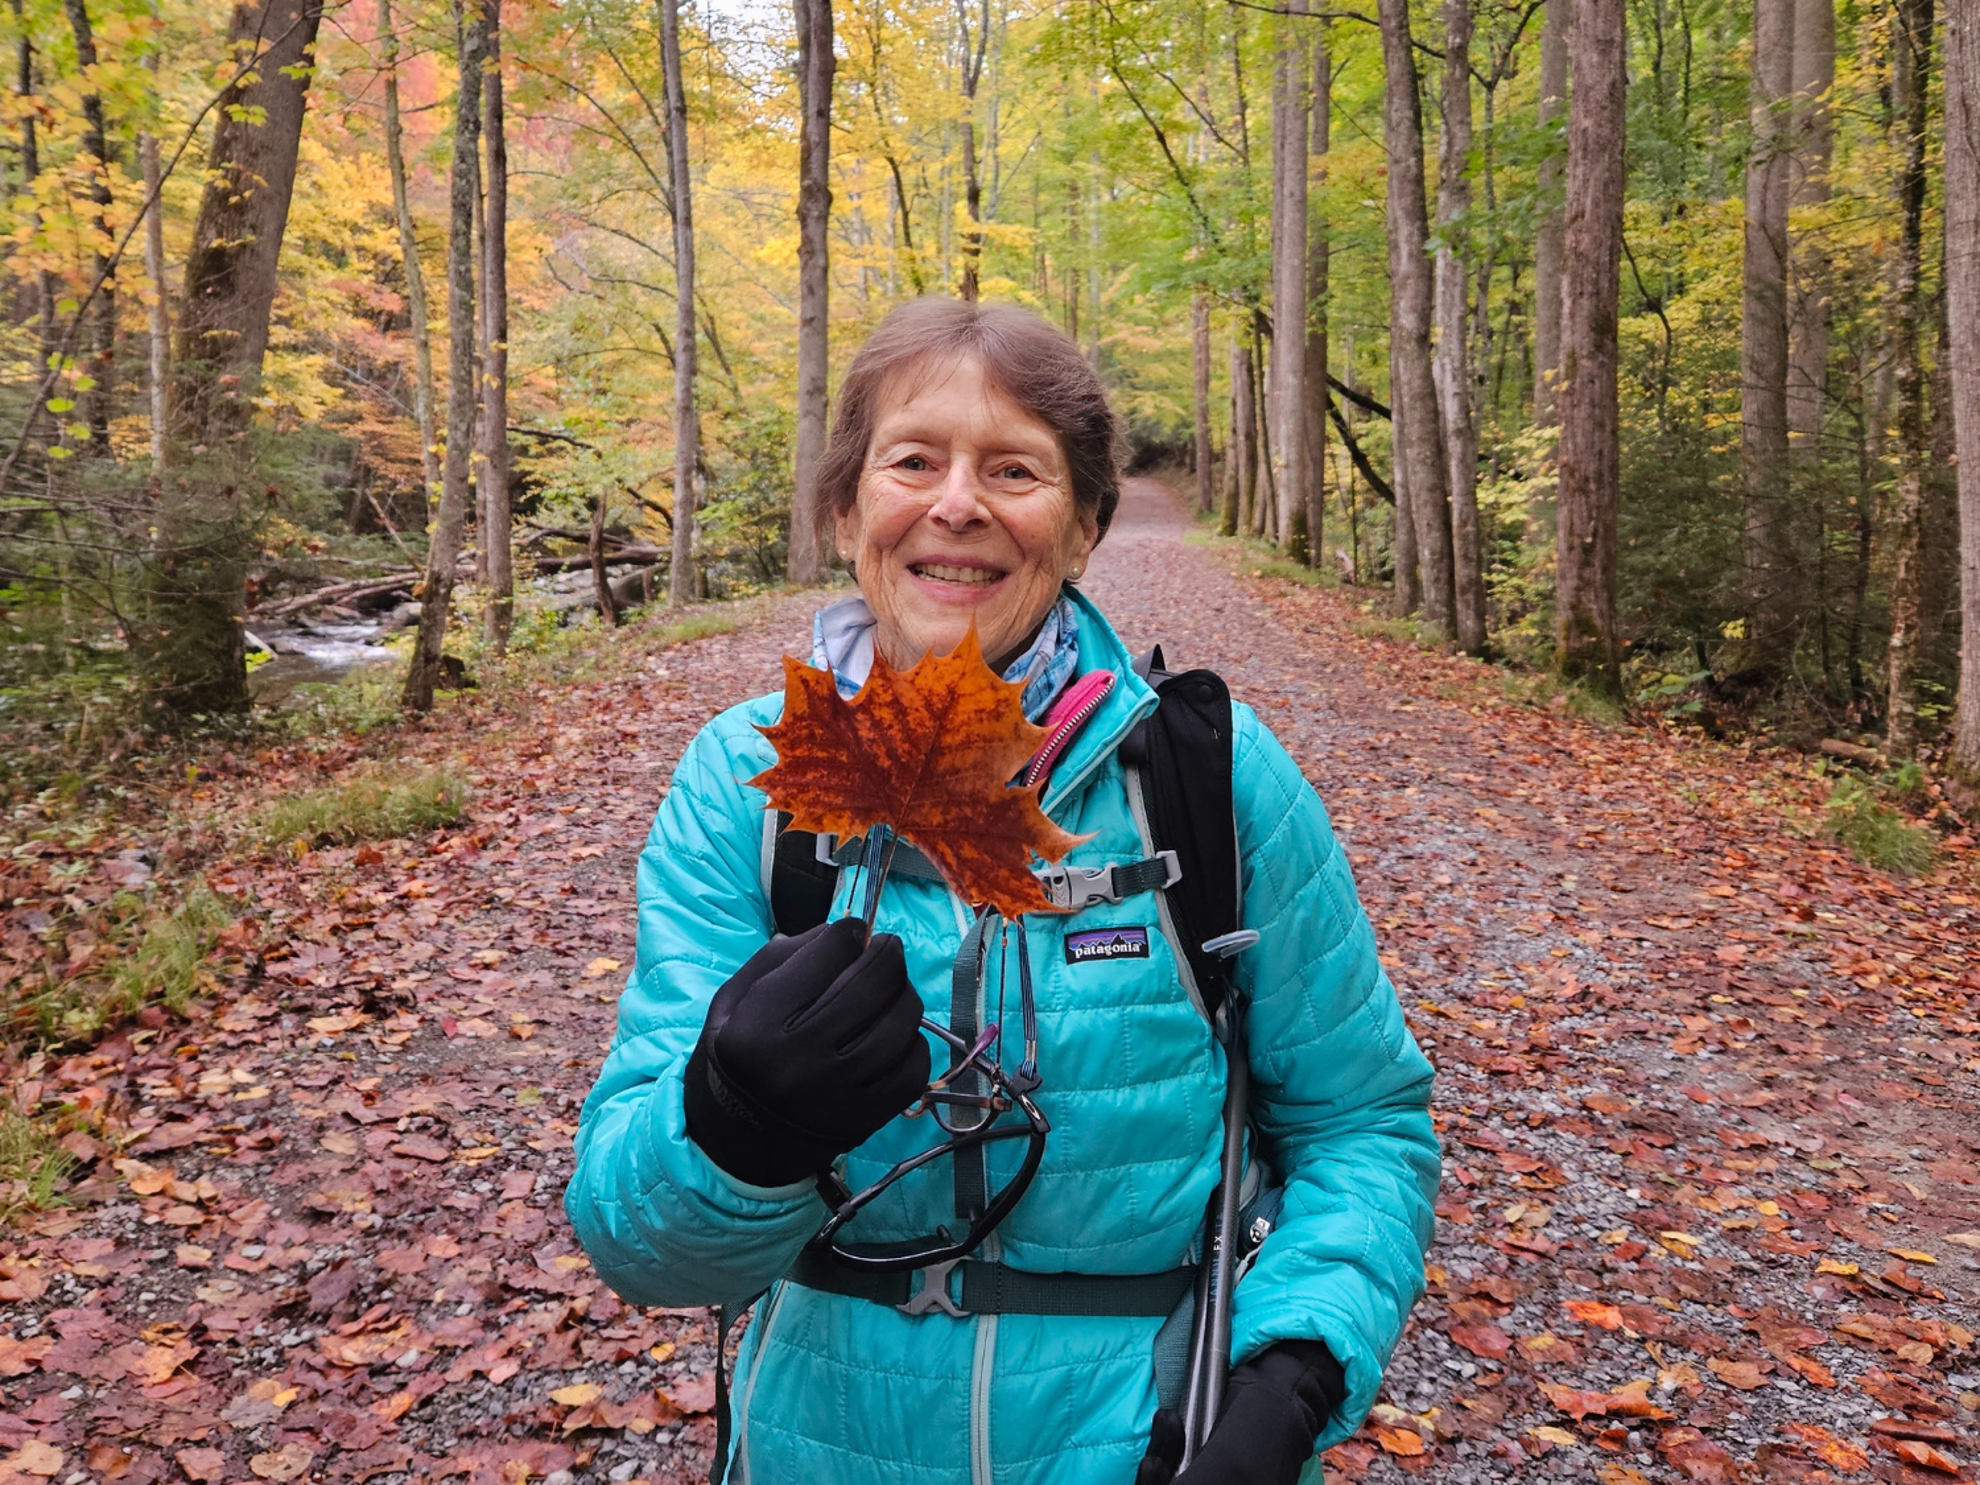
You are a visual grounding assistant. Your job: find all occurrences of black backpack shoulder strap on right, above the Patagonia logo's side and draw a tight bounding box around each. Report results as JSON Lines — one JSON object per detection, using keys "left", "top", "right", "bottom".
{"left": 1121, "top": 661, "right": 1241, "bottom": 1020}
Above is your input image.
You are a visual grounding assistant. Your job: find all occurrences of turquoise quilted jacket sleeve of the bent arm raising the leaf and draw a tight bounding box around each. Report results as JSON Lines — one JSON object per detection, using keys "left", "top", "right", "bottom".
{"left": 564, "top": 709, "right": 824, "bottom": 1305}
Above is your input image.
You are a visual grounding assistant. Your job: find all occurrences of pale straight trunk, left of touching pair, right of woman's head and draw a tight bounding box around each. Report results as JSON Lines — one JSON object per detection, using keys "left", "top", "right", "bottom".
{"left": 1267, "top": 0, "right": 1309, "bottom": 556}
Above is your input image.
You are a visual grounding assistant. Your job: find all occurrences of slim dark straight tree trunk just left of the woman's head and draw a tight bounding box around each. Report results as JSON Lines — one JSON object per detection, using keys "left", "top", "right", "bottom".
{"left": 788, "top": 0, "right": 834, "bottom": 582}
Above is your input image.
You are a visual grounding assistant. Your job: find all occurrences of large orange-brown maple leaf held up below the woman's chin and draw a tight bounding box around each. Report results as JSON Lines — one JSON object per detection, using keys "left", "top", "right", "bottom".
{"left": 748, "top": 628, "right": 1087, "bottom": 919}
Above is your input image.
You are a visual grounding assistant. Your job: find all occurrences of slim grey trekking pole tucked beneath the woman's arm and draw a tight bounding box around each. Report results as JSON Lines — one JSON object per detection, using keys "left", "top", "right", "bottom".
{"left": 1182, "top": 929, "right": 1257, "bottom": 1469}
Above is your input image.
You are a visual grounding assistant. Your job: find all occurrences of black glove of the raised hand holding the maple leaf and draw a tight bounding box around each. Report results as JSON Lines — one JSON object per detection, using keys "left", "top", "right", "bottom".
{"left": 683, "top": 919, "right": 929, "bottom": 1186}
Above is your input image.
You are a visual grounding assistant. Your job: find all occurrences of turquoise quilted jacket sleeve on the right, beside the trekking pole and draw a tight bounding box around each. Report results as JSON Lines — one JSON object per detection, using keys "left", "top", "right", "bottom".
{"left": 1232, "top": 707, "right": 1439, "bottom": 1447}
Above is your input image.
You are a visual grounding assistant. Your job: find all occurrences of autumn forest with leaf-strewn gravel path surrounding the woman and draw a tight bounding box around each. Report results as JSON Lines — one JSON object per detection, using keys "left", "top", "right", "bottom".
{"left": 0, "top": 0, "right": 1980, "bottom": 1485}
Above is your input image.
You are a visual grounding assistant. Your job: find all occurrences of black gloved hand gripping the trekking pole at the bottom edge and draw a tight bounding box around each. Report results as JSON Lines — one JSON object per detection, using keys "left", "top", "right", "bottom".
{"left": 1135, "top": 1340, "right": 1348, "bottom": 1485}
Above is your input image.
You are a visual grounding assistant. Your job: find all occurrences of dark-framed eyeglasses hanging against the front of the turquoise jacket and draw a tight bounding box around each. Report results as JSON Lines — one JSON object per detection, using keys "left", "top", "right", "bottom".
{"left": 810, "top": 879, "right": 1051, "bottom": 1271}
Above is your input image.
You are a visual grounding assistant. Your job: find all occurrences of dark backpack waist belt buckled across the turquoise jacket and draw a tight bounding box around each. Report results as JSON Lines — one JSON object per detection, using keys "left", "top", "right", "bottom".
{"left": 790, "top": 1249, "right": 1196, "bottom": 1319}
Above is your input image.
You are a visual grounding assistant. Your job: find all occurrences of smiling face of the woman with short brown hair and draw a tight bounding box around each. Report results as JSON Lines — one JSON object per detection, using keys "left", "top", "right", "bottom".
{"left": 838, "top": 358, "right": 1099, "bottom": 669}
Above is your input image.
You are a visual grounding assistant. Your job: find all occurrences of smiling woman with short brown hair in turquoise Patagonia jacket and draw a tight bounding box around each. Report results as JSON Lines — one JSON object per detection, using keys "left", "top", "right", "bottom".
{"left": 564, "top": 299, "right": 1437, "bottom": 1485}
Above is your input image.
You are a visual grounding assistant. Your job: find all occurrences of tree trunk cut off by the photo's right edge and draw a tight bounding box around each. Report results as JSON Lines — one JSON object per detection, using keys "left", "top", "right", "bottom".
{"left": 1944, "top": 4, "right": 1980, "bottom": 792}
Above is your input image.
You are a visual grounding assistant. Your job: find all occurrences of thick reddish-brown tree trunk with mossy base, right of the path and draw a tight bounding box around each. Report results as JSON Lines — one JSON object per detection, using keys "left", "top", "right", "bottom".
{"left": 1554, "top": 0, "right": 1626, "bottom": 695}
